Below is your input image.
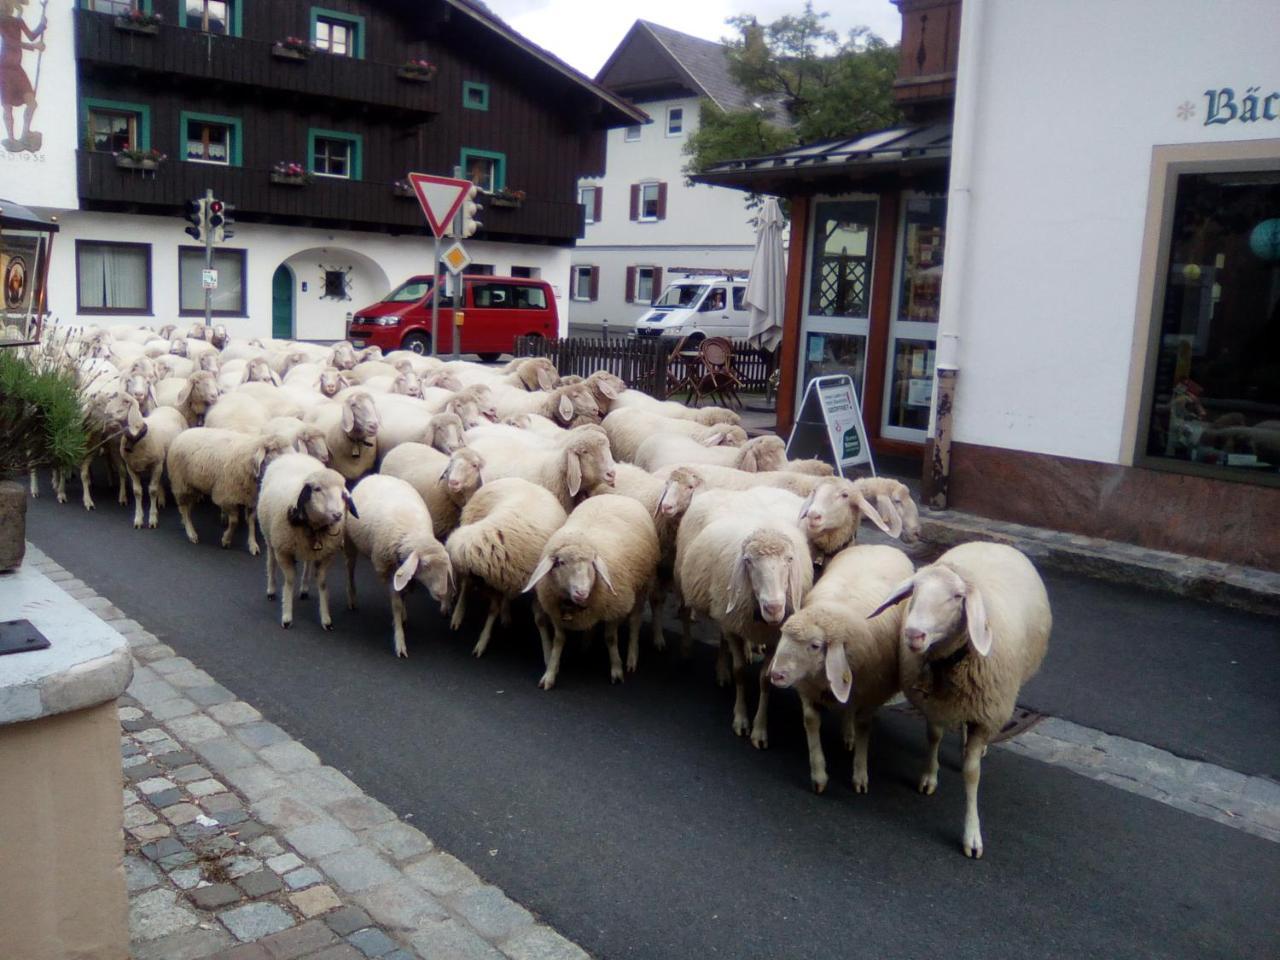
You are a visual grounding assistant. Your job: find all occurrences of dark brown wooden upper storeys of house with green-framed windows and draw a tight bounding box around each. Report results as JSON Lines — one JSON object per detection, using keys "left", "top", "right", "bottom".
{"left": 76, "top": 0, "right": 643, "bottom": 244}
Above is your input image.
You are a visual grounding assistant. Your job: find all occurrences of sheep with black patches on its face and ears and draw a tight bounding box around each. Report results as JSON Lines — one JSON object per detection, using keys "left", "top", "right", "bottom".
{"left": 257, "top": 453, "right": 358, "bottom": 630}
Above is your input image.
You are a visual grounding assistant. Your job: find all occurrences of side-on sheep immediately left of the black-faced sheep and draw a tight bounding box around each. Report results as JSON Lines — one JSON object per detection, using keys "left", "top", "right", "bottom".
{"left": 165, "top": 426, "right": 292, "bottom": 557}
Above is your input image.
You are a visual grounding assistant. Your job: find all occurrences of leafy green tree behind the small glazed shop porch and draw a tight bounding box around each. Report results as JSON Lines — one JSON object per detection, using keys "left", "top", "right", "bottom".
{"left": 685, "top": 0, "right": 901, "bottom": 174}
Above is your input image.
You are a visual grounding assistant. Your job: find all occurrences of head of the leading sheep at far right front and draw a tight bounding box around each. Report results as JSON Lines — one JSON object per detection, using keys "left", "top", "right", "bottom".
{"left": 868, "top": 563, "right": 992, "bottom": 657}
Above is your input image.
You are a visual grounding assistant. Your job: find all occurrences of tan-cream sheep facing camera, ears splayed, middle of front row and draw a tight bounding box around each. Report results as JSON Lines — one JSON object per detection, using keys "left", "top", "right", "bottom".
{"left": 525, "top": 494, "right": 658, "bottom": 690}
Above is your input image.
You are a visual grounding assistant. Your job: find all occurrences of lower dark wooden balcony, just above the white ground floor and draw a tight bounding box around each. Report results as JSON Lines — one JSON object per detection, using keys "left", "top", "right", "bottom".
{"left": 77, "top": 150, "right": 582, "bottom": 244}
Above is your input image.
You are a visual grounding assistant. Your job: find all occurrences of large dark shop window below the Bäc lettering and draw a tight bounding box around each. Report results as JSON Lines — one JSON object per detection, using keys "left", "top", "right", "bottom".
{"left": 1139, "top": 164, "right": 1280, "bottom": 484}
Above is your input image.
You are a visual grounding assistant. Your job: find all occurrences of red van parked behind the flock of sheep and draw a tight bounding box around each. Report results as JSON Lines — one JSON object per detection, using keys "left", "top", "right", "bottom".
{"left": 347, "top": 274, "right": 559, "bottom": 360}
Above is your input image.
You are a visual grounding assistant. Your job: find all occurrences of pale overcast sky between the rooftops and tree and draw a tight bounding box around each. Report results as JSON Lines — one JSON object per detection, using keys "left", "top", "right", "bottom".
{"left": 485, "top": 0, "right": 902, "bottom": 77}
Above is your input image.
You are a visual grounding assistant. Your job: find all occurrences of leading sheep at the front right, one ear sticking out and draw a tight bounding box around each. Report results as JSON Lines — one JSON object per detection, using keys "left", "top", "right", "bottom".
{"left": 870, "top": 543, "right": 1053, "bottom": 859}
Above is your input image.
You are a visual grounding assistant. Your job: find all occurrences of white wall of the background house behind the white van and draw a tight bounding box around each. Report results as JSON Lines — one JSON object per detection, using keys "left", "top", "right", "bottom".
{"left": 570, "top": 97, "right": 755, "bottom": 332}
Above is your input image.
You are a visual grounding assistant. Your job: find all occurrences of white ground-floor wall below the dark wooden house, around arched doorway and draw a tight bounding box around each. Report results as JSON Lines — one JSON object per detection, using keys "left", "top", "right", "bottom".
{"left": 49, "top": 212, "right": 571, "bottom": 340}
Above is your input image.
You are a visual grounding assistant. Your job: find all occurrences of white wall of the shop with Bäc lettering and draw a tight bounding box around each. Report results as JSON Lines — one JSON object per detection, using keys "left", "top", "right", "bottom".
{"left": 940, "top": 0, "right": 1280, "bottom": 462}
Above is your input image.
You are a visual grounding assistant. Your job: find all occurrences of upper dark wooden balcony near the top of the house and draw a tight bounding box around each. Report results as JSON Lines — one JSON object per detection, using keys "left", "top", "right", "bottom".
{"left": 74, "top": 10, "right": 439, "bottom": 120}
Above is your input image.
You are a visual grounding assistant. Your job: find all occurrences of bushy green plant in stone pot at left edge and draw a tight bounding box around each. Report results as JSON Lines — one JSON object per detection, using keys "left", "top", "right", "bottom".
{"left": 0, "top": 348, "right": 88, "bottom": 571}
